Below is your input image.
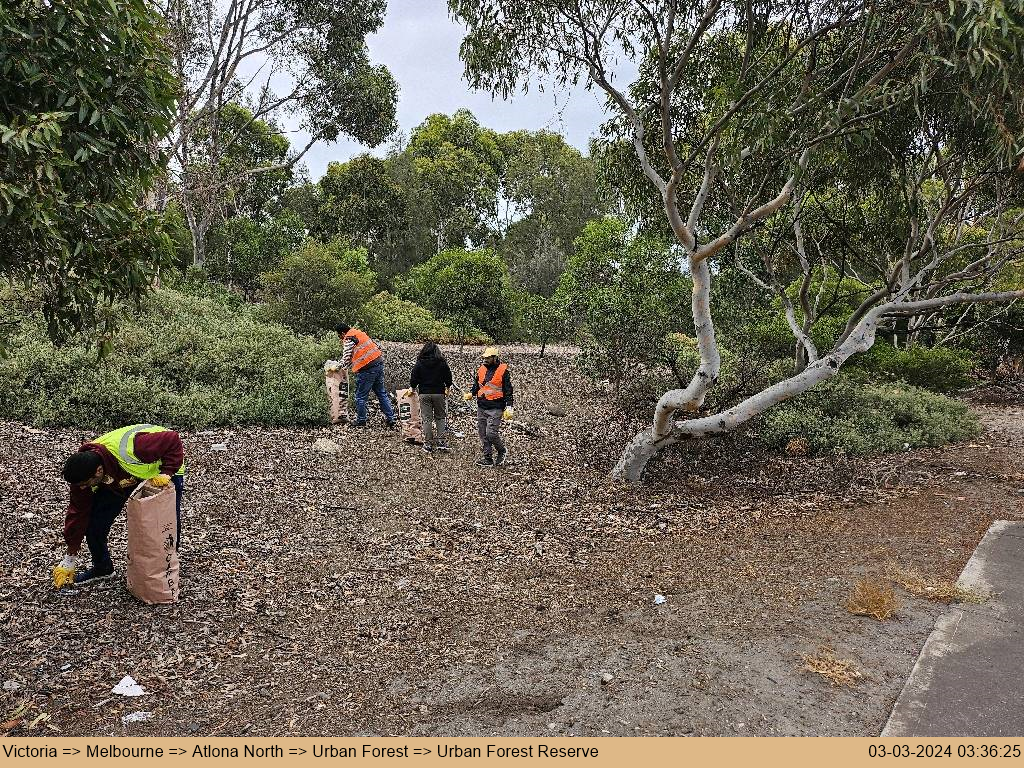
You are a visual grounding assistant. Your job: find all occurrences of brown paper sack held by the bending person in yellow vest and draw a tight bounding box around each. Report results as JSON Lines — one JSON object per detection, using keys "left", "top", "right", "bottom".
{"left": 126, "top": 482, "right": 178, "bottom": 605}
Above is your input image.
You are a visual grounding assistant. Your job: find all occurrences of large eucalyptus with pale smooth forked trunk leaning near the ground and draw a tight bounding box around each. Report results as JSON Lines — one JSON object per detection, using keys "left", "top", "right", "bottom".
{"left": 449, "top": 0, "right": 1024, "bottom": 480}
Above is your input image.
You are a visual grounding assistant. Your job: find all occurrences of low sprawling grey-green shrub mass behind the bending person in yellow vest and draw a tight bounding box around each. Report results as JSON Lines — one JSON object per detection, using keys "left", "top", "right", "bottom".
{"left": 0, "top": 290, "right": 338, "bottom": 431}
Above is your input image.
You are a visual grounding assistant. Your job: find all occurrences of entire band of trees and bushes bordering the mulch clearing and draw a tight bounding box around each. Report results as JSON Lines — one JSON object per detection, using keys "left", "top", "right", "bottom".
{"left": 0, "top": 0, "right": 1024, "bottom": 479}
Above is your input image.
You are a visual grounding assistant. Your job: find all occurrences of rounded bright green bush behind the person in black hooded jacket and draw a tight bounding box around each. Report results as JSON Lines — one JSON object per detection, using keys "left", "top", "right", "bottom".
{"left": 398, "top": 249, "right": 513, "bottom": 339}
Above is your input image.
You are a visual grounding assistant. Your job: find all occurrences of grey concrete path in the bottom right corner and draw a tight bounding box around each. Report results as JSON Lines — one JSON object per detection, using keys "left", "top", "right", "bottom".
{"left": 882, "top": 520, "right": 1024, "bottom": 736}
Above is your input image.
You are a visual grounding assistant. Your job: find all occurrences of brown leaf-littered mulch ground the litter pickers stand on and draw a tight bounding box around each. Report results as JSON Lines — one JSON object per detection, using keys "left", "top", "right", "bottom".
{"left": 0, "top": 350, "right": 1024, "bottom": 735}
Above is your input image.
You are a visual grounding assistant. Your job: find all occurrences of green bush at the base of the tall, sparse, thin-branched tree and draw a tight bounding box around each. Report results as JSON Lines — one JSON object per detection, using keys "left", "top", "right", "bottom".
{"left": 204, "top": 216, "right": 304, "bottom": 297}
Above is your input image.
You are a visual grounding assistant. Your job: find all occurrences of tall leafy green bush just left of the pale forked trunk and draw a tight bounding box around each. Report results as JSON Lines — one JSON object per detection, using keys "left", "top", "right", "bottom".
{"left": 556, "top": 217, "right": 690, "bottom": 389}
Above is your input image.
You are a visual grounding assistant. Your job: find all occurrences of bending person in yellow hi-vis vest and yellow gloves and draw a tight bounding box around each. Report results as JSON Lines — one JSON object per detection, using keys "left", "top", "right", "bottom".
{"left": 53, "top": 424, "right": 184, "bottom": 587}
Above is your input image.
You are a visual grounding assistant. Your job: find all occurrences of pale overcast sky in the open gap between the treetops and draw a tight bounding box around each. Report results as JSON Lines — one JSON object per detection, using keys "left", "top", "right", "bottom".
{"left": 292, "top": 0, "right": 603, "bottom": 180}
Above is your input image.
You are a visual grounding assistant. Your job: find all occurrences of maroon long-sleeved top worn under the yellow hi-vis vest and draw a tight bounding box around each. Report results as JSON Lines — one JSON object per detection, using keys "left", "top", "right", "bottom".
{"left": 65, "top": 430, "right": 185, "bottom": 555}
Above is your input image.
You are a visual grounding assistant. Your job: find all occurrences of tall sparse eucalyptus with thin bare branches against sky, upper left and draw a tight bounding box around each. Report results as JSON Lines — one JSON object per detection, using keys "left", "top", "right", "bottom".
{"left": 159, "top": 0, "right": 397, "bottom": 264}
